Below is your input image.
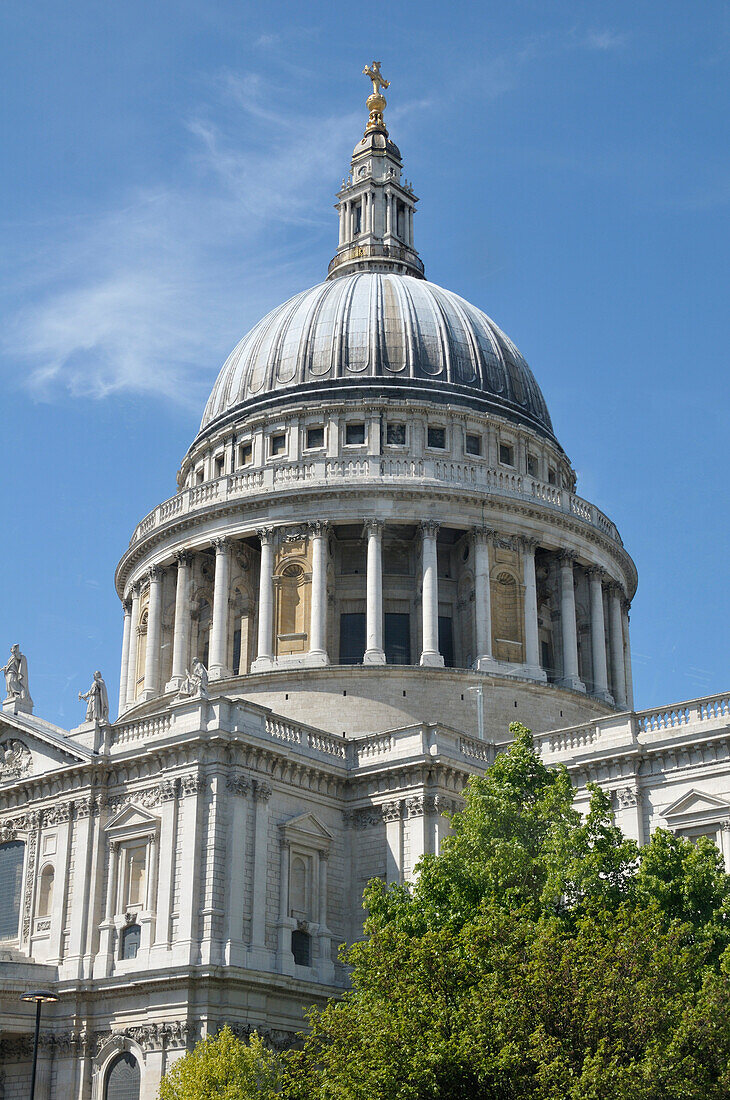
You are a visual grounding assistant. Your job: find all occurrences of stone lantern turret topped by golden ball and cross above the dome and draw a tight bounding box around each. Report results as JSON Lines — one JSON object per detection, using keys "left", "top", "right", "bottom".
{"left": 328, "top": 62, "right": 424, "bottom": 278}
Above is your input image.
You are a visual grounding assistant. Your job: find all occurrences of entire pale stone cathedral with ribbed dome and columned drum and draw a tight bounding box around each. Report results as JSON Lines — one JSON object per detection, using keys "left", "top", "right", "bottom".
{"left": 0, "top": 69, "right": 730, "bottom": 1100}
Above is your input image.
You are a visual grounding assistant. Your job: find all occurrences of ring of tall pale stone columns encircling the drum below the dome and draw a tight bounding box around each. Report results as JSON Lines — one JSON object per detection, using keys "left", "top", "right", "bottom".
{"left": 120, "top": 519, "right": 633, "bottom": 710}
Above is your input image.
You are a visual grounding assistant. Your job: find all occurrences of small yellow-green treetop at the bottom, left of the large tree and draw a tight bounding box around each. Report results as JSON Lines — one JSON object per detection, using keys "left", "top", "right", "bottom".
{"left": 159, "top": 1026, "right": 283, "bottom": 1100}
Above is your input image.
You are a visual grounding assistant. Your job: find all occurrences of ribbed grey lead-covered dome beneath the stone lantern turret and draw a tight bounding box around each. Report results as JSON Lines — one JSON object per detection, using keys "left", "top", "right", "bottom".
{"left": 200, "top": 271, "right": 554, "bottom": 439}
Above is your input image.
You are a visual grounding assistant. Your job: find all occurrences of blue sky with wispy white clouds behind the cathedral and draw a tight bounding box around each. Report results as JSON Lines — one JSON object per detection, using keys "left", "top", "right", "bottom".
{"left": 0, "top": 0, "right": 730, "bottom": 726}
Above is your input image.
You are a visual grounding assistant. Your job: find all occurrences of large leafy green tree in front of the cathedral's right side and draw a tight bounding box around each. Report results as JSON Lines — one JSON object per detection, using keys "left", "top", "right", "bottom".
{"left": 285, "top": 725, "right": 730, "bottom": 1100}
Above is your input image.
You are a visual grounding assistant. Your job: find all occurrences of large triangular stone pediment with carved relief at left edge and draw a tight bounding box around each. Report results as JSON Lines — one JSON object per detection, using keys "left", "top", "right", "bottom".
{"left": 0, "top": 712, "right": 96, "bottom": 784}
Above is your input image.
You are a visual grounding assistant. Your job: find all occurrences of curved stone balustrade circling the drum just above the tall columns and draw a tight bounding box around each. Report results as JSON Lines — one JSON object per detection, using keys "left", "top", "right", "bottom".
{"left": 130, "top": 455, "right": 623, "bottom": 547}
